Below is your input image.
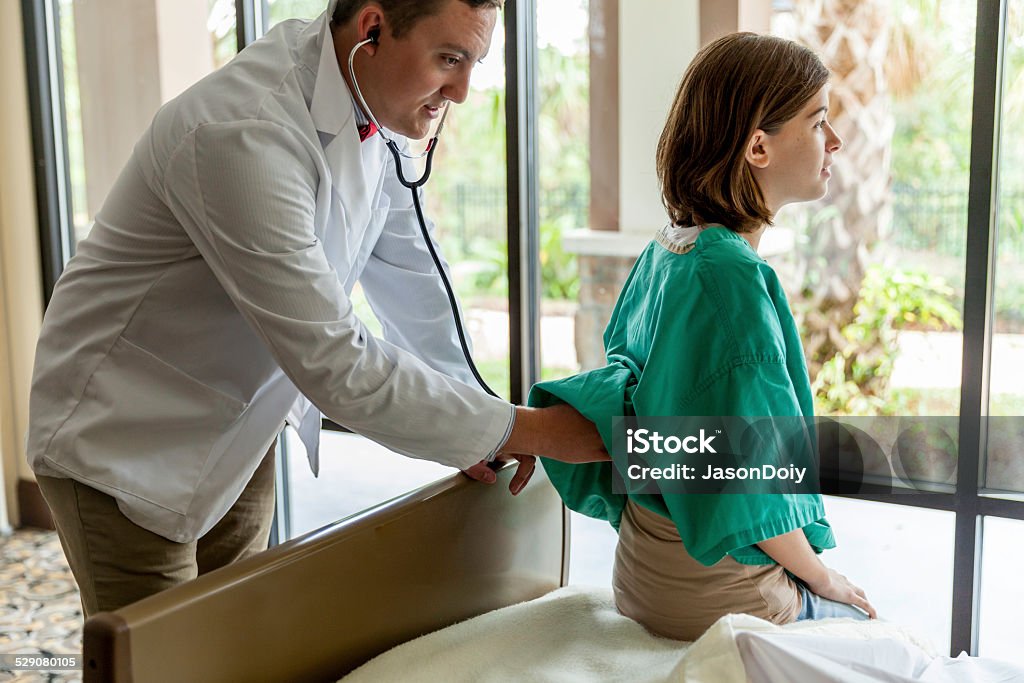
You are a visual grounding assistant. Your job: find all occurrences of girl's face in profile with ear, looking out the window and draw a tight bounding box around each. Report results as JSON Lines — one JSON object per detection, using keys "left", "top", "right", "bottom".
{"left": 745, "top": 85, "right": 843, "bottom": 215}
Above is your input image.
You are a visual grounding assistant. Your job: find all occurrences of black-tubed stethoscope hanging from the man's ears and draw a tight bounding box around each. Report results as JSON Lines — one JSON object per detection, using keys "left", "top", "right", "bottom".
{"left": 348, "top": 34, "right": 498, "bottom": 397}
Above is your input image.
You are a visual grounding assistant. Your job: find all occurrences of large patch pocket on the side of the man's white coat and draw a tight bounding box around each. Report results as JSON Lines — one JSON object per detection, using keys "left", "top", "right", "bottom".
{"left": 50, "top": 337, "right": 247, "bottom": 514}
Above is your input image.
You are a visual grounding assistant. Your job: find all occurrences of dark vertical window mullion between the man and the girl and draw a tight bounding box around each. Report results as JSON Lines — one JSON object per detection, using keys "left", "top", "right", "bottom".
{"left": 505, "top": 0, "right": 541, "bottom": 403}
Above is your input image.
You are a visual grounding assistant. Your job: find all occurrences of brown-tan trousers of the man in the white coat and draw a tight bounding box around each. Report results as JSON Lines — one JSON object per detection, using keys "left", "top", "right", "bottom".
{"left": 37, "top": 446, "right": 274, "bottom": 617}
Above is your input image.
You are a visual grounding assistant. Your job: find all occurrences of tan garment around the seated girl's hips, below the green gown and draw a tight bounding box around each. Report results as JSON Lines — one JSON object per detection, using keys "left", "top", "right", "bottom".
{"left": 611, "top": 502, "right": 801, "bottom": 640}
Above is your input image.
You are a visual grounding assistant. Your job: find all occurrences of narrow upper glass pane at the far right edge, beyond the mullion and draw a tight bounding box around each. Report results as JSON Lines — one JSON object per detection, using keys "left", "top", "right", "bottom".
{"left": 985, "top": 0, "right": 1024, "bottom": 492}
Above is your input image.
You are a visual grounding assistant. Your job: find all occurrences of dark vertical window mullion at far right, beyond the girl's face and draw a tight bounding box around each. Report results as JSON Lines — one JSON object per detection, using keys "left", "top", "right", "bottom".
{"left": 950, "top": 0, "right": 1006, "bottom": 656}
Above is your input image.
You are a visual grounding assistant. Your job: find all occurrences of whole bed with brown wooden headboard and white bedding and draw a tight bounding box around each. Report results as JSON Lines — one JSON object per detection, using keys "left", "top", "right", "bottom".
{"left": 83, "top": 467, "right": 1024, "bottom": 683}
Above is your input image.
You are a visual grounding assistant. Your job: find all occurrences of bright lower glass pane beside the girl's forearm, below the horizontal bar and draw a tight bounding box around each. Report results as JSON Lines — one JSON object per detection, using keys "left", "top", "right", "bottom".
{"left": 821, "top": 496, "right": 954, "bottom": 651}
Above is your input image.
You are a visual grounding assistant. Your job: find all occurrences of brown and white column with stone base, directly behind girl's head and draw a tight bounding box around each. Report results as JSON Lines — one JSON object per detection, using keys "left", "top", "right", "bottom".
{"left": 565, "top": 0, "right": 699, "bottom": 370}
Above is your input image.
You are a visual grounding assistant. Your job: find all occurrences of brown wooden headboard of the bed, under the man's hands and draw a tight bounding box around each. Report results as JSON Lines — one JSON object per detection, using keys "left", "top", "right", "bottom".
{"left": 83, "top": 466, "right": 568, "bottom": 683}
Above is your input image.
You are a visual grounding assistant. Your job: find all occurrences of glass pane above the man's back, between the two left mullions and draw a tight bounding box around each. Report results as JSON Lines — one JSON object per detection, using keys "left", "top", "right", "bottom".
{"left": 57, "top": 0, "right": 236, "bottom": 243}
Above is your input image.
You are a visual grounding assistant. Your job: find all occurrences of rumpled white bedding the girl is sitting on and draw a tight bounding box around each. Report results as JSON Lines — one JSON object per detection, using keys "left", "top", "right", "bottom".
{"left": 342, "top": 586, "right": 1024, "bottom": 683}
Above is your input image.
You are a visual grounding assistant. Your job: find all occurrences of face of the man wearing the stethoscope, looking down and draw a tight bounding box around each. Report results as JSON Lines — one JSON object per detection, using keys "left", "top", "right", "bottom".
{"left": 355, "top": 0, "right": 498, "bottom": 139}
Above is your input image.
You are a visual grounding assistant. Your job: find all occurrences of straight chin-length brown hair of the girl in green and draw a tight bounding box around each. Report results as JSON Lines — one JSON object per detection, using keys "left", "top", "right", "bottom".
{"left": 656, "top": 33, "right": 828, "bottom": 232}
